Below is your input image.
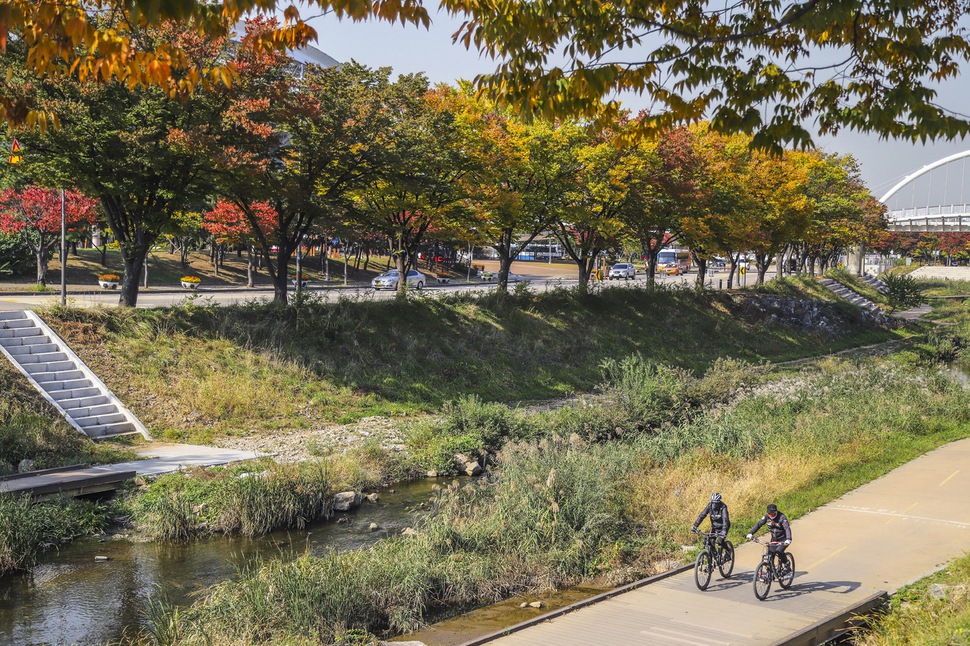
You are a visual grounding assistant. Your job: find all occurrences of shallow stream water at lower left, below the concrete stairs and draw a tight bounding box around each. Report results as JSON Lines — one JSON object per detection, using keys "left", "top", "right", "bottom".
{"left": 0, "top": 480, "right": 434, "bottom": 645}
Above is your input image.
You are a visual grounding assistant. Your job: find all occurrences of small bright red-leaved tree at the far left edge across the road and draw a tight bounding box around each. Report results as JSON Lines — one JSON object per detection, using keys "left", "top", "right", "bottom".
{"left": 0, "top": 186, "right": 98, "bottom": 285}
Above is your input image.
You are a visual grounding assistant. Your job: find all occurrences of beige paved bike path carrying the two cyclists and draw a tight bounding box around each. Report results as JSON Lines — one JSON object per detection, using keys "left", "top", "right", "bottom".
{"left": 482, "top": 439, "right": 970, "bottom": 646}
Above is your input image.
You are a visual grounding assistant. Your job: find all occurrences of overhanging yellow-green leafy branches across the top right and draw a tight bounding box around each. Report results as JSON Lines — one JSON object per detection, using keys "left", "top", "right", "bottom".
{"left": 442, "top": 0, "right": 970, "bottom": 148}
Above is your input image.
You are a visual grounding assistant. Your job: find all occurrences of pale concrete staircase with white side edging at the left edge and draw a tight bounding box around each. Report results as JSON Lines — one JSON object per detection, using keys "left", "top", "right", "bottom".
{"left": 0, "top": 310, "right": 151, "bottom": 439}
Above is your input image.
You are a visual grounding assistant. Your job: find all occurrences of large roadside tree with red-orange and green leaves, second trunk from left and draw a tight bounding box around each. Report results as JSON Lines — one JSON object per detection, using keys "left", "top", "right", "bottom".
{"left": 215, "top": 38, "right": 405, "bottom": 303}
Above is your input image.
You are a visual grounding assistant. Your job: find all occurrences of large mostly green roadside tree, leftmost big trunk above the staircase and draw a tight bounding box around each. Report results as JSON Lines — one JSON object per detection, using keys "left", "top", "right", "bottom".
{"left": 0, "top": 26, "right": 227, "bottom": 306}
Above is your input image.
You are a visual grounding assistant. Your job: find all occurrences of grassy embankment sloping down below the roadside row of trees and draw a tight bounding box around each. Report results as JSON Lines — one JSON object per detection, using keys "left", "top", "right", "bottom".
{"left": 41, "top": 281, "right": 897, "bottom": 442}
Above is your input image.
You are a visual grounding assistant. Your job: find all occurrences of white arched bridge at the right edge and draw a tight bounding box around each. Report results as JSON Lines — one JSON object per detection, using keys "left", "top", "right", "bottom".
{"left": 879, "top": 150, "right": 970, "bottom": 231}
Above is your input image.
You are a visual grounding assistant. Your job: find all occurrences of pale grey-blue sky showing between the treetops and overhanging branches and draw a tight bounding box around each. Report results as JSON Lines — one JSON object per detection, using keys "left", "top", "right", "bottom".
{"left": 310, "top": 8, "right": 970, "bottom": 197}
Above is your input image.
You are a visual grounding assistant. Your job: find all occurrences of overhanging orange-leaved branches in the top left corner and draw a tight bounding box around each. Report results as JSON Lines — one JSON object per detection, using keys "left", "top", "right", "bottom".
{"left": 0, "top": 0, "right": 430, "bottom": 128}
